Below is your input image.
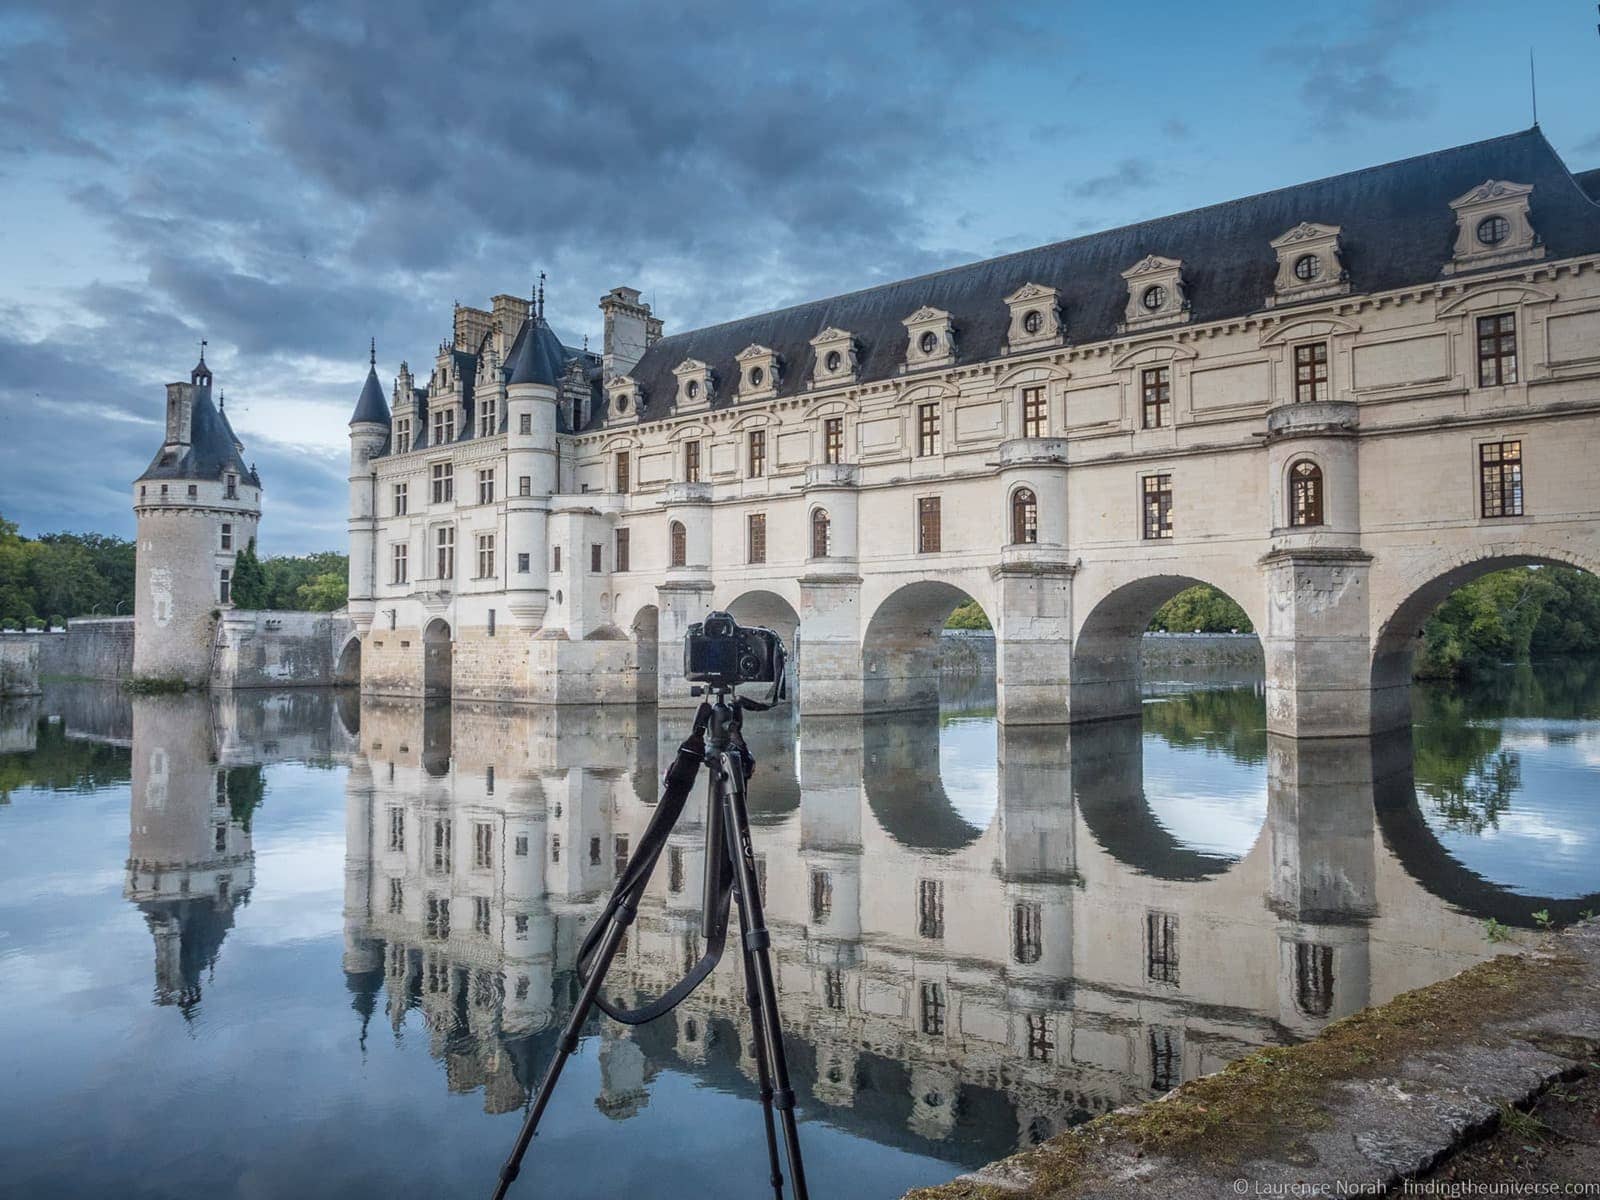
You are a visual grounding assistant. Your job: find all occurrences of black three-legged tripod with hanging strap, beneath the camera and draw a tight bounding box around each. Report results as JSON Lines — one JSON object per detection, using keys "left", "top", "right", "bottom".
{"left": 494, "top": 686, "right": 808, "bottom": 1200}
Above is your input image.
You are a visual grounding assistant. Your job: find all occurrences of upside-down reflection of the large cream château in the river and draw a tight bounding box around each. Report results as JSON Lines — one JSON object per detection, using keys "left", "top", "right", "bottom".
{"left": 334, "top": 701, "right": 1483, "bottom": 1162}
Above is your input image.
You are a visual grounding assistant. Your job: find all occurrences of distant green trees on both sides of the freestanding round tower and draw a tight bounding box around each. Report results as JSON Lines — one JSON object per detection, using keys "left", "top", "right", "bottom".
{"left": 0, "top": 517, "right": 349, "bottom": 629}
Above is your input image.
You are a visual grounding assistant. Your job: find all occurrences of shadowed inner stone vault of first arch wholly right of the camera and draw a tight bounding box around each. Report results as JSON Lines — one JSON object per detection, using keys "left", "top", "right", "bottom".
{"left": 861, "top": 579, "right": 994, "bottom": 712}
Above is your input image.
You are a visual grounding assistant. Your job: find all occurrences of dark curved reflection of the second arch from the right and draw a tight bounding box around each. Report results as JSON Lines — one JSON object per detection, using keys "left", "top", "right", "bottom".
{"left": 1072, "top": 718, "right": 1238, "bottom": 882}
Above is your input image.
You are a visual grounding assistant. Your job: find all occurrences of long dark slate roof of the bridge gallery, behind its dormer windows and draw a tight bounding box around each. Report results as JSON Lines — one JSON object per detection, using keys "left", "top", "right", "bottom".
{"left": 604, "top": 128, "right": 1600, "bottom": 426}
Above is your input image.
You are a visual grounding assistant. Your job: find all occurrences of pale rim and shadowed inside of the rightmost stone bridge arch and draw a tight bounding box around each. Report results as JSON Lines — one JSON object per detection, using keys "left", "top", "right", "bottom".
{"left": 1371, "top": 541, "right": 1600, "bottom": 733}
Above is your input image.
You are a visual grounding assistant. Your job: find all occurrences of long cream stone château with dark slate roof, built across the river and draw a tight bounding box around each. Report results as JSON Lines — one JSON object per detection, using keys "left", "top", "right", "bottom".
{"left": 350, "top": 130, "right": 1600, "bottom": 734}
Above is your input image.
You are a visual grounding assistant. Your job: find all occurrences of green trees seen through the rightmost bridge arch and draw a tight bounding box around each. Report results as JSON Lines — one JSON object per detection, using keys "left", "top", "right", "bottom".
{"left": 1413, "top": 566, "right": 1600, "bottom": 678}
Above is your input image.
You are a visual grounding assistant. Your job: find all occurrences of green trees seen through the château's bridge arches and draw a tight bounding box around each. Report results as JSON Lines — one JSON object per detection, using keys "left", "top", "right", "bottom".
{"left": 946, "top": 566, "right": 1600, "bottom": 678}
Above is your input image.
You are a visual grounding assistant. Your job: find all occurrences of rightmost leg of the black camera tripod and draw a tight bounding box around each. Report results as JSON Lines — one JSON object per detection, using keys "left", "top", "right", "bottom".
{"left": 715, "top": 752, "right": 810, "bottom": 1200}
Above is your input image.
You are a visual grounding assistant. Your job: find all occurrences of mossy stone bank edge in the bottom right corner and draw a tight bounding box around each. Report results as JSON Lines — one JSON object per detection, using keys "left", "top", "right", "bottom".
{"left": 907, "top": 920, "right": 1600, "bottom": 1200}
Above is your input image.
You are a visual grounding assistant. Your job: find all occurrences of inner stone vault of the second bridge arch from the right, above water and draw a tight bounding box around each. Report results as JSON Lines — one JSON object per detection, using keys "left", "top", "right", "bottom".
{"left": 1070, "top": 574, "right": 1261, "bottom": 722}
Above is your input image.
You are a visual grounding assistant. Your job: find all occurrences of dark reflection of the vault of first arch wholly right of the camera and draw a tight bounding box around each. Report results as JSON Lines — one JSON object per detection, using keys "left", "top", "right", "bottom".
{"left": 861, "top": 712, "right": 984, "bottom": 854}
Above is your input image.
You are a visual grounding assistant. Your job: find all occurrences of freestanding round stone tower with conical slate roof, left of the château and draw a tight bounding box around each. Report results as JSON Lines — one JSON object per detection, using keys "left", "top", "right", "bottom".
{"left": 133, "top": 342, "right": 261, "bottom": 685}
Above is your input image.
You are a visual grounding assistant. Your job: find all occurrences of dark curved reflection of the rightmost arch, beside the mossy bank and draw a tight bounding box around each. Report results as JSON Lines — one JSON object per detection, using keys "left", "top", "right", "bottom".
{"left": 1373, "top": 730, "right": 1600, "bottom": 928}
